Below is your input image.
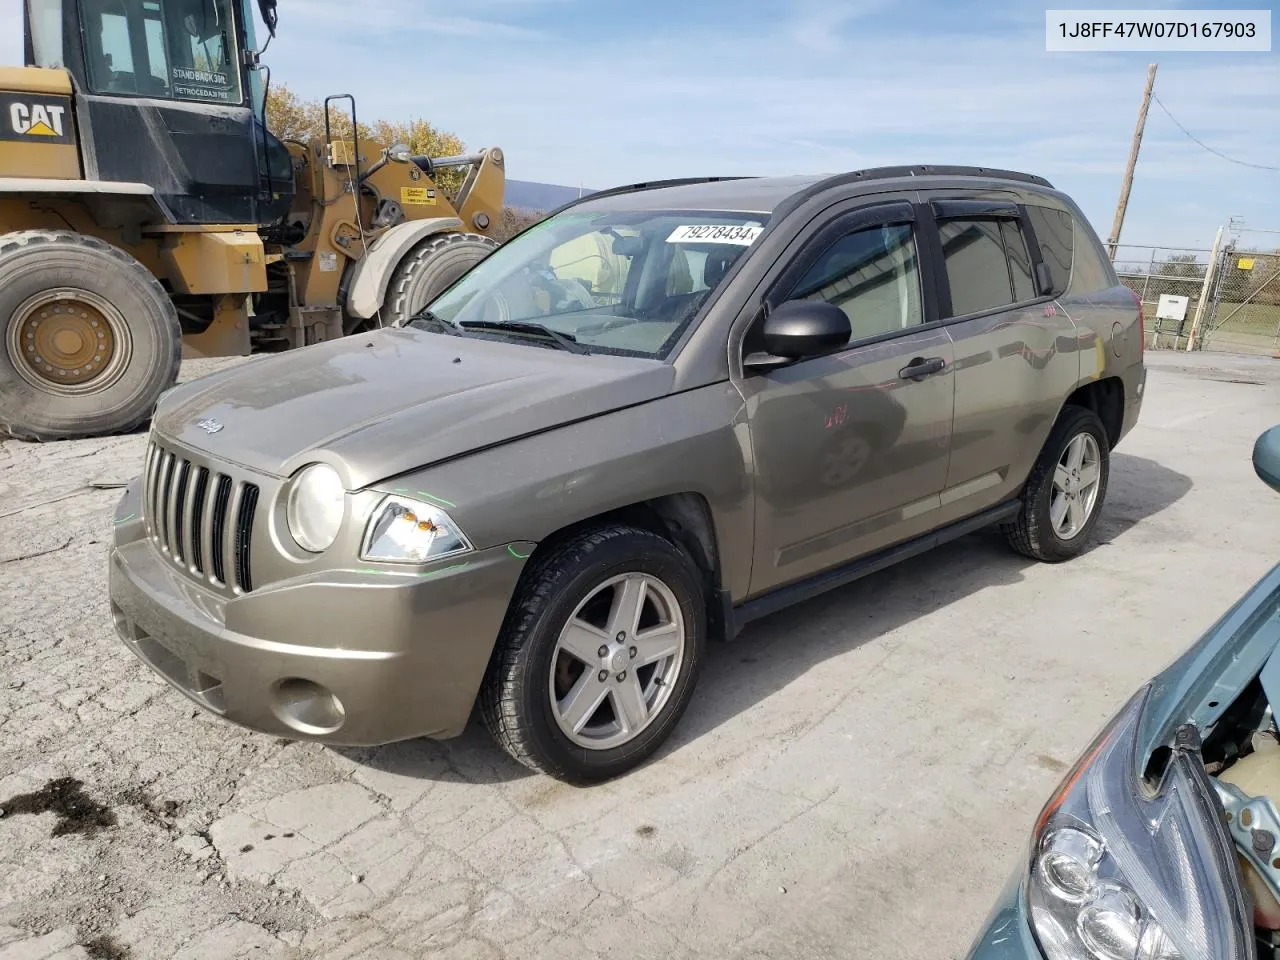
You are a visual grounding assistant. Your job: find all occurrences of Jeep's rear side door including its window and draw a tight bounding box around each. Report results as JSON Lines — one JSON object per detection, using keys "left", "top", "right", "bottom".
{"left": 920, "top": 191, "right": 1079, "bottom": 522}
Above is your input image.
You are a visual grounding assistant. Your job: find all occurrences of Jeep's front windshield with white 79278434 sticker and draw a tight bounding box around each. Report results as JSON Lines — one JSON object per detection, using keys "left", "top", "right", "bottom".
{"left": 428, "top": 210, "right": 768, "bottom": 358}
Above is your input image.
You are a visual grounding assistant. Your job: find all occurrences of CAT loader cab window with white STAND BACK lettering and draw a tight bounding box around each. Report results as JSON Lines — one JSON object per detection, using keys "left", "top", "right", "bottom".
{"left": 81, "top": 0, "right": 243, "bottom": 104}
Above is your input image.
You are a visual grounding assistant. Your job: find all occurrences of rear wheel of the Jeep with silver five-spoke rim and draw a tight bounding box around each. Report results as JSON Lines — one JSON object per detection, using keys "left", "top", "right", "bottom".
{"left": 1001, "top": 406, "right": 1111, "bottom": 563}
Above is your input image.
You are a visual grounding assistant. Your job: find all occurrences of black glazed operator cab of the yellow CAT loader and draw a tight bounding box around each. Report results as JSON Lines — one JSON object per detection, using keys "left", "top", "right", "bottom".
{"left": 26, "top": 0, "right": 294, "bottom": 224}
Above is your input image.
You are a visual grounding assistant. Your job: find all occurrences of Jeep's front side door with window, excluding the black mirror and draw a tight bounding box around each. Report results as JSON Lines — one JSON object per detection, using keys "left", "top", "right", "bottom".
{"left": 741, "top": 200, "right": 952, "bottom": 594}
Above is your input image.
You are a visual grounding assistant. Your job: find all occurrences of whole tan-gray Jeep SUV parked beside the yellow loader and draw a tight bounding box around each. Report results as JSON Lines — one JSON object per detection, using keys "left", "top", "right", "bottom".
{"left": 110, "top": 166, "right": 1146, "bottom": 782}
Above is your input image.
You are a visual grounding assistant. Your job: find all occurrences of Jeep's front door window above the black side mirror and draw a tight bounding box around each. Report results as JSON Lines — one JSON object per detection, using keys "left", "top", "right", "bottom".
{"left": 788, "top": 224, "right": 923, "bottom": 340}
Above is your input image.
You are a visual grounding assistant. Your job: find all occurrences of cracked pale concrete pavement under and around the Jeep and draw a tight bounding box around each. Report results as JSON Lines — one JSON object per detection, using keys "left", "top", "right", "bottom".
{"left": 0, "top": 353, "right": 1280, "bottom": 960}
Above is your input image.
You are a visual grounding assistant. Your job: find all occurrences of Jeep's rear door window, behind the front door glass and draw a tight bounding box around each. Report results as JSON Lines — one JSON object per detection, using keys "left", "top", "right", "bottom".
{"left": 938, "top": 218, "right": 1036, "bottom": 316}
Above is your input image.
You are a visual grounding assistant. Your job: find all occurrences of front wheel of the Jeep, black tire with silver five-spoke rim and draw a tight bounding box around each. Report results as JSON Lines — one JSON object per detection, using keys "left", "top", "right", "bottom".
{"left": 480, "top": 526, "right": 707, "bottom": 783}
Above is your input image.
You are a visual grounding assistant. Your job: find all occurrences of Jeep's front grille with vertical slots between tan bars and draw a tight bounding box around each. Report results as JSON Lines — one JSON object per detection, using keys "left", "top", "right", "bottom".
{"left": 142, "top": 440, "right": 259, "bottom": 593}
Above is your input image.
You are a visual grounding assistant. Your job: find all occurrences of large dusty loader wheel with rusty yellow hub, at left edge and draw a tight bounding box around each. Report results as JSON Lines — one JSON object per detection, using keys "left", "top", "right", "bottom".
{"left": 0, "top": 230, "right": 182, "bottom": 440}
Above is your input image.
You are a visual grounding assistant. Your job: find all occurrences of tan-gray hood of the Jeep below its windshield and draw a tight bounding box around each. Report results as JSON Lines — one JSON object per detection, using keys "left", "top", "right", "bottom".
{"left": 154, "top": 328, "right": 675, "bottom": 489}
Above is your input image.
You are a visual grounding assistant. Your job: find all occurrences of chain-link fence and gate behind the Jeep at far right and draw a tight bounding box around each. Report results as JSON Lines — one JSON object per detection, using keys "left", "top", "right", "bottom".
{"left": 1115, "top": 229, "right": 1280, "bottom": 355}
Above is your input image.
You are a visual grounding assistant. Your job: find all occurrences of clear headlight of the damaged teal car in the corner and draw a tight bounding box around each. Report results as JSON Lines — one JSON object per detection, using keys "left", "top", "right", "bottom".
{"left": 1027, "top": 690, "right": 1251, "bottom": 960}
